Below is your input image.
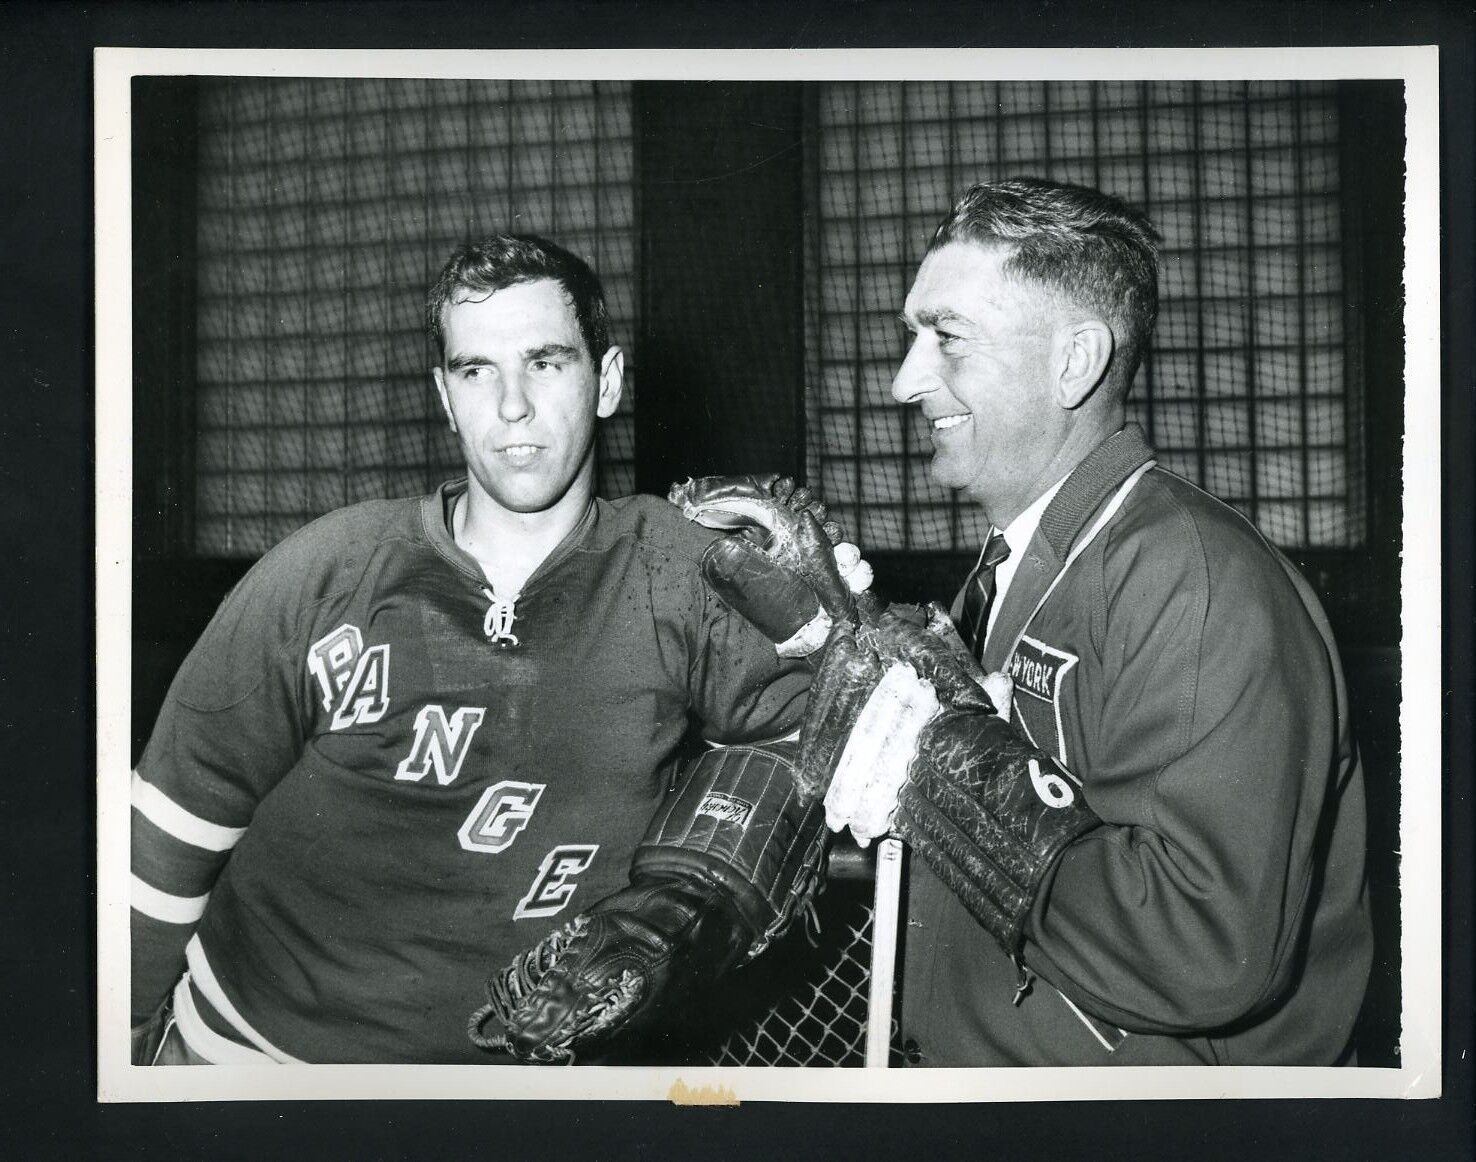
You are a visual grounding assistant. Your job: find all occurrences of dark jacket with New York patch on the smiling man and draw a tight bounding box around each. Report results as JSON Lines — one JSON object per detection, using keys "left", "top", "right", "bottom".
{"left": 902, "top": 427, "right": 1373, "bottom": 1066}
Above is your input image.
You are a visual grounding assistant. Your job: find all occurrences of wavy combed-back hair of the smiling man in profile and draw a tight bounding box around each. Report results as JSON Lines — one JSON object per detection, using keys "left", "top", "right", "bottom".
{"left": 928, "top": 177, "right": 1159, "bottom": 388}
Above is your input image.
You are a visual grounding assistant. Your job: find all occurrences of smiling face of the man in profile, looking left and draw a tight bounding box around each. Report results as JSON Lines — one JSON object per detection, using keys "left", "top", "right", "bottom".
{"left": 892, "top": 242, "right": 1067, "bottom": 518}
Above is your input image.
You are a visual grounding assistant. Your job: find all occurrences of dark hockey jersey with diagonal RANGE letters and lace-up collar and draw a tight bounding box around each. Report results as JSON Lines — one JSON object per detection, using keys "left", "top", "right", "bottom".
{"left": 133, "top": 481, "right": 809, "bottom": 1062}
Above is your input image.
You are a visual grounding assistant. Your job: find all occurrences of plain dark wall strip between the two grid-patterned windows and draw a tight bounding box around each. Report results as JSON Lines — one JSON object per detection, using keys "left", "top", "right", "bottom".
{"left": 635, "top": 81, "right": 804, "bottom": 493}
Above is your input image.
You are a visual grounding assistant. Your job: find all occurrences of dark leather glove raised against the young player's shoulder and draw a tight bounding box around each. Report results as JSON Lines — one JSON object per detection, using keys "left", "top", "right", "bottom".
{"left": 667, "top": 475, "right": 871, "bottom": 657}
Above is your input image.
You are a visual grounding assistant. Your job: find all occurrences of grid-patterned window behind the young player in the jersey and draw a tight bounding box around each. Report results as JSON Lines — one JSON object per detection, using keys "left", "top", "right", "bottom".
{"left": 195, "top": 78, "right": 638, "bottom": 557}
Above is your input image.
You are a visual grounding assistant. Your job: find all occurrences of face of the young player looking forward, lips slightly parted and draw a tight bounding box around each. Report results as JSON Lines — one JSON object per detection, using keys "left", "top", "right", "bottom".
{"left": 432, "top": 279, "right": 623, "bottom": 512}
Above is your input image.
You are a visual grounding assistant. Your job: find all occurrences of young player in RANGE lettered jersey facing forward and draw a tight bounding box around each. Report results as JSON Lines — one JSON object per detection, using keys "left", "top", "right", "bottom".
{"left": 131, "top": 236, "right": 824, "bottom": 1065}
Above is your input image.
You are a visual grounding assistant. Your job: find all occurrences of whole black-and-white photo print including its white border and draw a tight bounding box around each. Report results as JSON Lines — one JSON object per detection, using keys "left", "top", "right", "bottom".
{"left": 96, "top": 47, "right": 1442, "bottom": 1104}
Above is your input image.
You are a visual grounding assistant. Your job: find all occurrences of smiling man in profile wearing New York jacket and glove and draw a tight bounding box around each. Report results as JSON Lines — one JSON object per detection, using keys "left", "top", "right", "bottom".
{"left": 696, "top": 179, "right": 1371, "bottom": 1066}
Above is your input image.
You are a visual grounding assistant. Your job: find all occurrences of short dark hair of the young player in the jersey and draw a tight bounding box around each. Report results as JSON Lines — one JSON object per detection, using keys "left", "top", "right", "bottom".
{"left": 425, "top": 233, "right": 610, "bottom": 366}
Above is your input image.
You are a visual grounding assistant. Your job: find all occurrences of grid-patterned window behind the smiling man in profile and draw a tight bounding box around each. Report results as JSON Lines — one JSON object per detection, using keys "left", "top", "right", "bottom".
{"left": 807, "top": 81, "right": 1365, "bottom": 551}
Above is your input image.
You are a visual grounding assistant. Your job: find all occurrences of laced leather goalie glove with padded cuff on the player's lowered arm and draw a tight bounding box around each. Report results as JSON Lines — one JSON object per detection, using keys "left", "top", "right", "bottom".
{"left": 468, "top": 746, "right": 825, "bottom": 1063}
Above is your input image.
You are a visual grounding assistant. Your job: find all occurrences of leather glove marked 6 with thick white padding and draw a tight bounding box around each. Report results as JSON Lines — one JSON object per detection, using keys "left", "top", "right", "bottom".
{"left": 799, "top": 608, "right": 1100, "bottom": 955}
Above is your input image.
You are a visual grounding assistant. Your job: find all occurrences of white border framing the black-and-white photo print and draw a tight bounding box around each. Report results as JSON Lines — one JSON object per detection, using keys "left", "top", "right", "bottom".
{"left": 94, "top": 46, "right": 1442, "bottom": 1101}
